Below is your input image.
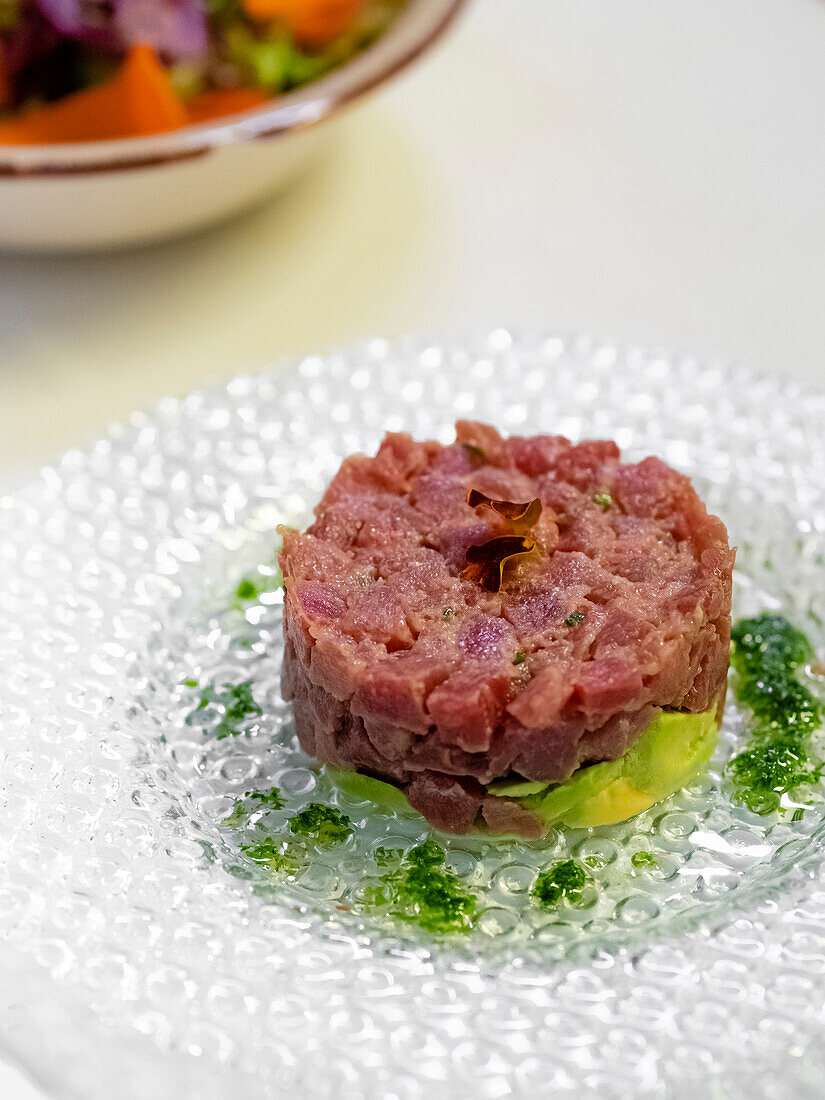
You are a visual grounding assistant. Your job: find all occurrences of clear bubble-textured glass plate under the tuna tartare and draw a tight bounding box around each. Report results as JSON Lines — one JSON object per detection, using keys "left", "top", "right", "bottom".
{"left": 0, "top": 330, "right": 825, "bottom": 1100}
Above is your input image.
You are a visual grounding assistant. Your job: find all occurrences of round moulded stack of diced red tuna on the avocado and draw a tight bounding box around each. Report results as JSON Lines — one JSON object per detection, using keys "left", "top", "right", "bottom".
{"left": 281, "top": 421, "right": 734, "bottom": 835}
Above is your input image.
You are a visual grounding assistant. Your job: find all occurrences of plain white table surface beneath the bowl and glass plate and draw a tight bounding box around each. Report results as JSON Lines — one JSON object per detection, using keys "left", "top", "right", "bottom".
{"left": 0, "top": 0, "right": 825, "bottom": 1100}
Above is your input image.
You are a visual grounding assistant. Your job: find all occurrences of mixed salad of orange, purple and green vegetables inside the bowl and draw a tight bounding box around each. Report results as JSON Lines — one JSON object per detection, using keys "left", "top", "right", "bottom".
{"left": 0, "top": 0, "right": 405, "bottom": 144}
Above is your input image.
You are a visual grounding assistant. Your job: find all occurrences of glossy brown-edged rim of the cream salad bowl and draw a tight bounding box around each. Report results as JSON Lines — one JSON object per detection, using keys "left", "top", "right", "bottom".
{"left": 0, "top": 0, "right": 468, "bottom": 179}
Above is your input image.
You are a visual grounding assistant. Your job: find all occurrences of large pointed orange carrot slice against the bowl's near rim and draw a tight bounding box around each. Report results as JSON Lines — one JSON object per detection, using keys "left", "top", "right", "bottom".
{"left": 0, "top": 46, "right": 189, "bottom": 145}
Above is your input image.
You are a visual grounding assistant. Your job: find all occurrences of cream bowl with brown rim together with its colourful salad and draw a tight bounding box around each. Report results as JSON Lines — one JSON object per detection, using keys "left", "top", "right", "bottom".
{"left": 0, "top": 0, "right": 463, "bottom": 251}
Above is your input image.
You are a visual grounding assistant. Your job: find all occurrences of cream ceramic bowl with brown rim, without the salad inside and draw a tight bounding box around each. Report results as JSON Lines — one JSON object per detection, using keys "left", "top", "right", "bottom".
{"left": 0, "top": 0, "right": 464, "bottom": 251}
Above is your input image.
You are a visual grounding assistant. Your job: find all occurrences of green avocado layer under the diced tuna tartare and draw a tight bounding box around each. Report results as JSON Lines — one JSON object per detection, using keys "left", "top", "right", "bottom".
{"left": 327, "top": 710, "right": 719, "bottom": 828}
